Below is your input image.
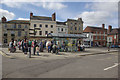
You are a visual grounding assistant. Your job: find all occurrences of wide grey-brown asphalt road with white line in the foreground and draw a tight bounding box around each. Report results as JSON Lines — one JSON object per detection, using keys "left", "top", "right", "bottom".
{"left": 2, "top": 52, "right": 119, "bottom": 78}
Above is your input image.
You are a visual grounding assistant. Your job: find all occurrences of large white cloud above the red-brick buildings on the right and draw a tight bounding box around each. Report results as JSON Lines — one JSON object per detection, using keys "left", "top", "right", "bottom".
{"left": 75, "top": 2, "right": 118, "bottom": 28}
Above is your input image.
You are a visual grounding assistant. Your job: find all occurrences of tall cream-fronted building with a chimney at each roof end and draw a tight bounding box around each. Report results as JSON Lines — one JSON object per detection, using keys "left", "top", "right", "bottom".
{"left": 30, "top": 13, "right": 57, "bottom": 39}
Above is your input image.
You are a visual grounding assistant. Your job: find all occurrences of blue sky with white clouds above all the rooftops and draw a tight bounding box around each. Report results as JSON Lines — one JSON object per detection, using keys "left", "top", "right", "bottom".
{"left": 0, "top": 0, "right": 118, "bottom": 29}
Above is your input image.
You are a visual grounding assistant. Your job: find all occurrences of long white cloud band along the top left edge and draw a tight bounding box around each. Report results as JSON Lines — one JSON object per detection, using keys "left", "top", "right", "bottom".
{"left": 1, "top": 0, "right": 67, "bottom": 10}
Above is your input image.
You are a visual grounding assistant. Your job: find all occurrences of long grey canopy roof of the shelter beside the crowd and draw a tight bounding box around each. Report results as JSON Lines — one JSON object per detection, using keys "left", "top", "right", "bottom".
{"left": 47, "top": 33, "right": 86, "bottom": 38}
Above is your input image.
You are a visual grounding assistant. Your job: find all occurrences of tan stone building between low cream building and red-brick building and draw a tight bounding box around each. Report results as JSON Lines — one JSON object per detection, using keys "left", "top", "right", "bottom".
{"left": 66, "top": 18, "right": 83, "bottom": 34}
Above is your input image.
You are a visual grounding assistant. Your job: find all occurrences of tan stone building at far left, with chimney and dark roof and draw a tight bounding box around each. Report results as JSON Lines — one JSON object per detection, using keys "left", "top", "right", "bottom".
{"left": 1, "top": 17, "right": 30, "bottom": 46}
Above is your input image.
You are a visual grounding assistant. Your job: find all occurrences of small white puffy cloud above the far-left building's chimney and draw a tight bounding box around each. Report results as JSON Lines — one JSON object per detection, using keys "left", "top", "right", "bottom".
{"left": 0, "top": 9, "right": 15, "bottom": 20}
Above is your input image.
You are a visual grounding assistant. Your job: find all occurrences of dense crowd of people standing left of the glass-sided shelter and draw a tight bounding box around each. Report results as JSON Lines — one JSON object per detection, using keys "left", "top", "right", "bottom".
{"left": 9, "top": 39, "right": 58, "bottom": 56}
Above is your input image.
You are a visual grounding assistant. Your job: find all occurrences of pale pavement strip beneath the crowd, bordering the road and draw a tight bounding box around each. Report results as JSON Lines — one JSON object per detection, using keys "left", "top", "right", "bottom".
{"left": 0, "top": 47, "right": 119, "bottom": 60}
